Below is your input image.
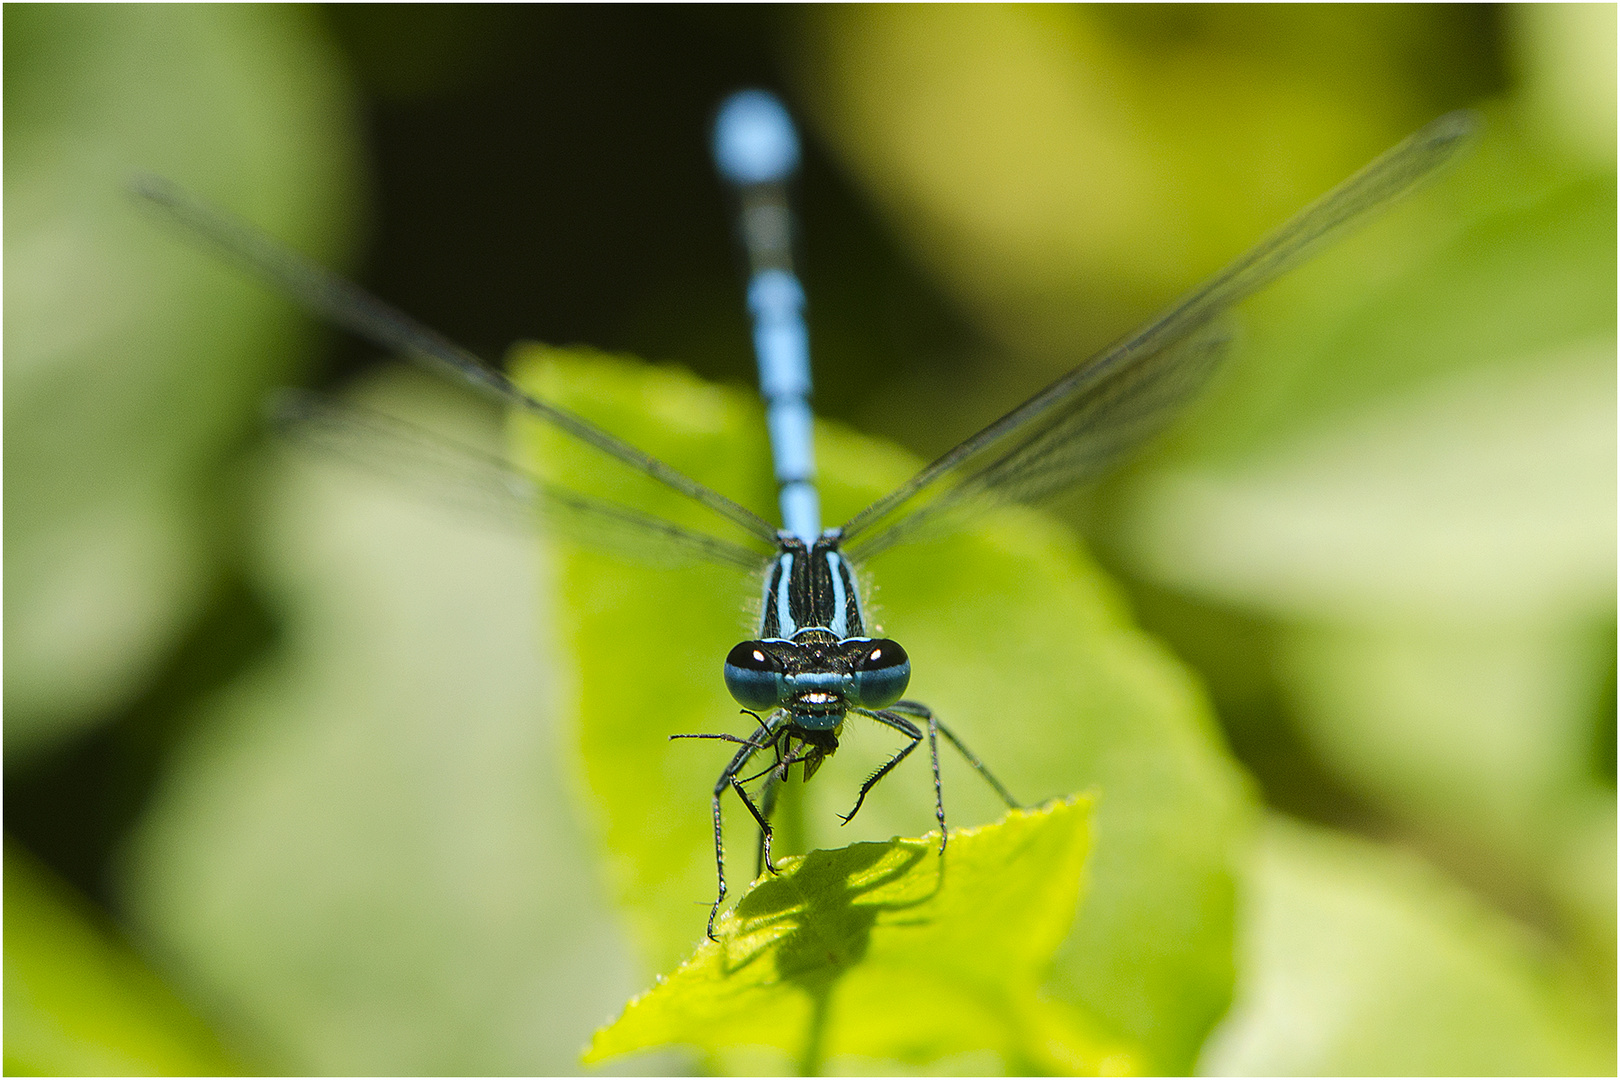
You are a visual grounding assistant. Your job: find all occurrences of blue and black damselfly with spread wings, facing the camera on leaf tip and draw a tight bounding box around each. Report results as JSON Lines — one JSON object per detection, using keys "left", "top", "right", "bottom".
{"left": 136, "top": 91, "right": 1474, "bottom": 936}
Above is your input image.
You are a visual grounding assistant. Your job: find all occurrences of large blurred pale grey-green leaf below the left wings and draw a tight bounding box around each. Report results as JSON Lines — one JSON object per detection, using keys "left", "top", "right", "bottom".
{"left": 126, "top": 376, "right": 635, "bottom": 1075}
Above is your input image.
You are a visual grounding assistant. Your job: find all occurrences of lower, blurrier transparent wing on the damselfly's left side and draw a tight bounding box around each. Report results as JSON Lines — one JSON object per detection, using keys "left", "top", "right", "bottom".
{"left": 271, "top": 390, "right": 774, "bottom": 572}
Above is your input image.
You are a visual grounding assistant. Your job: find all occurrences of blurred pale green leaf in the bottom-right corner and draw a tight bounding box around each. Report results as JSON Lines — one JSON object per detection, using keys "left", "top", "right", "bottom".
{"left": 1200, "top": 818, "right": 1614, "bottom": 1077}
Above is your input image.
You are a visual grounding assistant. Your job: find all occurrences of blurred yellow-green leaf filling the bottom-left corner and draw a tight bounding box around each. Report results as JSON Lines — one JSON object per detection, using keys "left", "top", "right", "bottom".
{"left": 5, "top": 840, "right": 237, "bottom": 1077}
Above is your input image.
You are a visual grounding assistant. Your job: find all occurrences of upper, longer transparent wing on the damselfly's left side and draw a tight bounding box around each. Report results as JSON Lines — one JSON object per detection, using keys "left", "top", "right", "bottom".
{"left": 131, "top": 176, "right": 776, "bottom": 544}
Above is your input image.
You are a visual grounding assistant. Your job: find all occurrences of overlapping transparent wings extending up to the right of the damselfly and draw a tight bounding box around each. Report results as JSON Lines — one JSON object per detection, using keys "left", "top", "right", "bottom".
{"left": 844, "top": 112, "right": 1476, "bottom": 559}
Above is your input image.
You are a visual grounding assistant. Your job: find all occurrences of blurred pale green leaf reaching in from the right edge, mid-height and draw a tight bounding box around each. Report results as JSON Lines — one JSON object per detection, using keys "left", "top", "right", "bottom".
{"left": 1121, "top": 337, "right": 1615, "bottom": 622}
